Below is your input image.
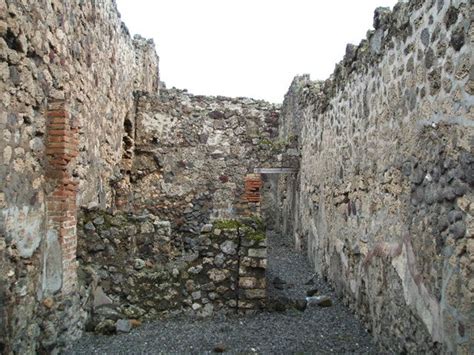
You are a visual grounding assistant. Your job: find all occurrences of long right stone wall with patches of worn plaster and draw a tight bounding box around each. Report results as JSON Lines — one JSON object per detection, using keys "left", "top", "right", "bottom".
{"left": 279, "top": 0, "right": 474, "bottom": 354}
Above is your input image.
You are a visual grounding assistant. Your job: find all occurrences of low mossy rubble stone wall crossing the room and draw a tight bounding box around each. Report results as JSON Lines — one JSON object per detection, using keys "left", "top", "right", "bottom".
{"left": 78, "top": 211, "right": 266, "bottom": 332}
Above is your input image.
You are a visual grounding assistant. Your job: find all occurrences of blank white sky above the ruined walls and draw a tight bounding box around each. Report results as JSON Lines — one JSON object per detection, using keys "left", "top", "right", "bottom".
{"left": 116, "top": 0, "right": 397, "bottom": 102}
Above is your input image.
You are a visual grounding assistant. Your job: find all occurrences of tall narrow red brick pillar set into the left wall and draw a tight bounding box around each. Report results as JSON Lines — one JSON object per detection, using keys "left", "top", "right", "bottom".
{"left": 46, "top": 100, "right": 79, "bottom": 294}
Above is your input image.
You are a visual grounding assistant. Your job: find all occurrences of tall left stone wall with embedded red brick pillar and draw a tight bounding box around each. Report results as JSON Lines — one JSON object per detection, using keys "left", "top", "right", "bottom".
{"left": 0, "top": 0, "right": 158, "bottom": 353}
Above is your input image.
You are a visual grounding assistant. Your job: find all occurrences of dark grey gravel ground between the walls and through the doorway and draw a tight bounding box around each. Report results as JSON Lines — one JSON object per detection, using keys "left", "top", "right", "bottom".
{"left": 66, "top": 235, "right": 376, "bottom": 355}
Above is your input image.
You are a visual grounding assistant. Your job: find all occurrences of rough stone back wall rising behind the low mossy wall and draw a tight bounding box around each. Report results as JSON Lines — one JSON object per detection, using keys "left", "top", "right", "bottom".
{"left": 116, "top": 89, "right": 281, "bottom": 234}
